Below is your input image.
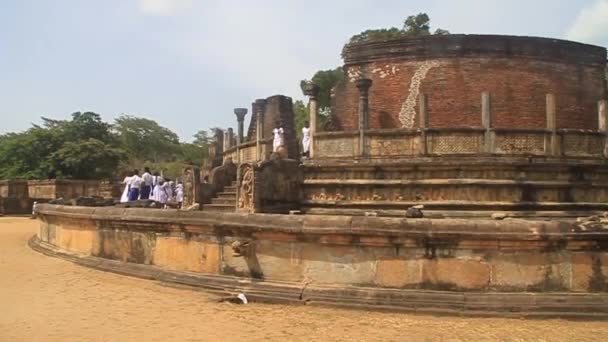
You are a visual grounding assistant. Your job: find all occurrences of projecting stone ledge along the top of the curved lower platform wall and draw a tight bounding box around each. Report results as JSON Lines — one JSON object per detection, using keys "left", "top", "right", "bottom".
{"left": 36, "top": 204, "right": 608, "bottom": 250}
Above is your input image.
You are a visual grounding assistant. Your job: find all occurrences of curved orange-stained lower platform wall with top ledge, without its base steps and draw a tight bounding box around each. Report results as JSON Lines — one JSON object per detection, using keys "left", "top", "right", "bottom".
{"left": 37, "top": 205, "right": 608, "bottom": 294}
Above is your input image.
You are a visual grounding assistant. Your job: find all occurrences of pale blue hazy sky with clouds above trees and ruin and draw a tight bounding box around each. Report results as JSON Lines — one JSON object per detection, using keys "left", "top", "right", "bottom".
{"left": 0, "top": 0, "right": 608, "bottom": 141}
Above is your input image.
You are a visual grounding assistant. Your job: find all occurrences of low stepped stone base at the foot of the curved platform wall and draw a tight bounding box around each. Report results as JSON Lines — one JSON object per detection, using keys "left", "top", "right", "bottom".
{"left": 29, "top": 236, "right": 608, "bottom": 319}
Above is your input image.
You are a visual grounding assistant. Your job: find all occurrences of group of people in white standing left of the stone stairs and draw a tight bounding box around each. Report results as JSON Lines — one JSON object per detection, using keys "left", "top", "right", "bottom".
{"left": 120, "top": 167, "right": 184, "bottom": 208}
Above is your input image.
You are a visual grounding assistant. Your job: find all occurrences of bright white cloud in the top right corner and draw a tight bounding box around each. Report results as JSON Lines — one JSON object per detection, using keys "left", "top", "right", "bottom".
{"left": 566, "top": 0, "right": 608, "bottom": 45}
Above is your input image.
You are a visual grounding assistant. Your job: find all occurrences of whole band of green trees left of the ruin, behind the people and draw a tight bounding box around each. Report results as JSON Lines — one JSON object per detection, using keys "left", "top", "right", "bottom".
{"left": 0, "top": 112, "right": 216, "bottom": 179}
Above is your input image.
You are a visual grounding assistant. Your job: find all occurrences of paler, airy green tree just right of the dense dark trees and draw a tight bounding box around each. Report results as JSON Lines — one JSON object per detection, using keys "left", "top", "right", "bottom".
{"left": 114, "top": 115, "right": 180, "bottom": 163}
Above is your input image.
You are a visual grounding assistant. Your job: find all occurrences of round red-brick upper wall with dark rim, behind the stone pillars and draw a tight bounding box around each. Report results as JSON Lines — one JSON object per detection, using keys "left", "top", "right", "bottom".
{"left": 332, "top": 35, "right": 606, "bottom": 130}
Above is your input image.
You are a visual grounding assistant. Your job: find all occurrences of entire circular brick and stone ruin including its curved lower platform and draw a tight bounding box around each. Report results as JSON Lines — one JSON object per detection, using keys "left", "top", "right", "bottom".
{"left": 31, "top": 35, "right": 608, "bottom": 318}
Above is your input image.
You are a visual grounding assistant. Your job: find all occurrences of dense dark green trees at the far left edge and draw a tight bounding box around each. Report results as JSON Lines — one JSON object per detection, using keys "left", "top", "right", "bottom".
{"left": 0, "top": 112, "right": 125, "bottom": 179}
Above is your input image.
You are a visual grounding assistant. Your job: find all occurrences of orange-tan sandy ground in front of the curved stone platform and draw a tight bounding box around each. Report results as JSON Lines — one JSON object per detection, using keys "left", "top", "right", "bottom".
{"left": 0, "top": 217, "right": 608, "bottom": 341}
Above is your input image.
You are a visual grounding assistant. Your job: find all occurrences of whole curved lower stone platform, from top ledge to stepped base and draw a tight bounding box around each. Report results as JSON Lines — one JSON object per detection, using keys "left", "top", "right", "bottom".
{"left": 31, "top": 204, "right": 608, "bottom": 318}
